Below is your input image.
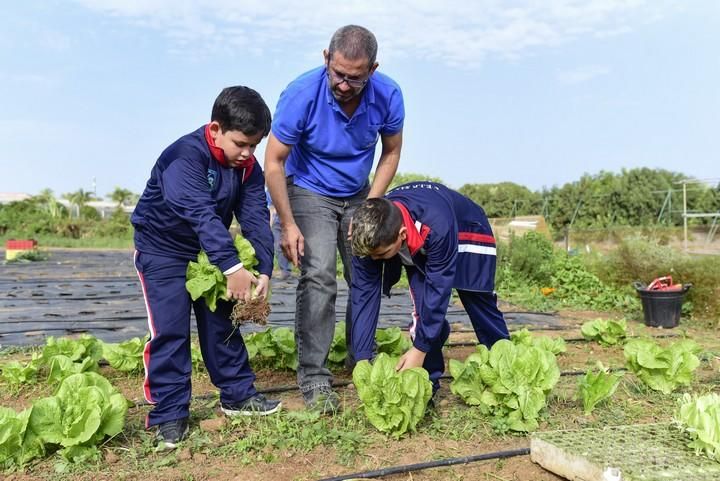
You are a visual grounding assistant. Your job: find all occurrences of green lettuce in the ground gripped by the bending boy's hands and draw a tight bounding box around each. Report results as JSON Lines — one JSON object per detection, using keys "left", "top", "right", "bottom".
{"left": 353, "top": 353, "right": 432, "bottom": 438}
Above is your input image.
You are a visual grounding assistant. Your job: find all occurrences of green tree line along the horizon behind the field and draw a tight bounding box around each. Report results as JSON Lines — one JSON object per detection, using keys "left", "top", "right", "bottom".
{"left": 0, "top": 168, "right": 720, "bottom": 237}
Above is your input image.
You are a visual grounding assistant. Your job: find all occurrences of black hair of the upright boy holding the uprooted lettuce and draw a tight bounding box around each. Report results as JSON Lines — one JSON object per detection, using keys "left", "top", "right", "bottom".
{"left": 210, "top": 85, "right": 272, "bottom": 137}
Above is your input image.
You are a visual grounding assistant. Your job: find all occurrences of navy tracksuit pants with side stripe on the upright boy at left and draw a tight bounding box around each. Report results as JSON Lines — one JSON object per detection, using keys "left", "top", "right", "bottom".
{"left": 135, "top": 252, "right": 257, "bottom": 427}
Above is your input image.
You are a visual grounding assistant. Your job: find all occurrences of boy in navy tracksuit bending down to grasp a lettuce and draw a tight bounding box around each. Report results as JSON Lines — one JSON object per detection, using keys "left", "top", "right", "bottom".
{"left": 350, "top": 182, "right": 508, "bottom": 393}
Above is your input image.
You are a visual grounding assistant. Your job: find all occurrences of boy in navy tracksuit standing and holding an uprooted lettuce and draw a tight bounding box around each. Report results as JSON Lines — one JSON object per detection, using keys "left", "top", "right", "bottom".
{"left": 132, "top": 87, "right": 280, "bottom": 448}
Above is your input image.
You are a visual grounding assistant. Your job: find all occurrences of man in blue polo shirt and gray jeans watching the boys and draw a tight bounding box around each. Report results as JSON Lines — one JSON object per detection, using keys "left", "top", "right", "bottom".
{"left": 265, "top": 25, "right": 405, "bottom": 413}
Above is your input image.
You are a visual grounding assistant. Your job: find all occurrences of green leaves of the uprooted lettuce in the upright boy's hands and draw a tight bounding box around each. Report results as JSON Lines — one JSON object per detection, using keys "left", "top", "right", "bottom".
{"left": 185, "top": 234, "right": 259, "bottom": 312}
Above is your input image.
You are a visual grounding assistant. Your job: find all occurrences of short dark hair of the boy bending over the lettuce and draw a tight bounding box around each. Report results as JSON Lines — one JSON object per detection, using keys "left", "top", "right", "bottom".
{"left": 351, "top": 198, "right": 403, "bottom": 257}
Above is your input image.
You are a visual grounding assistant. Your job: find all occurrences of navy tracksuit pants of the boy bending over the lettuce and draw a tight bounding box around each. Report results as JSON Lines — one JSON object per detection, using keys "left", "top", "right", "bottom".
{"left": 406, "top": 267, "right": 510, "bottom": 394}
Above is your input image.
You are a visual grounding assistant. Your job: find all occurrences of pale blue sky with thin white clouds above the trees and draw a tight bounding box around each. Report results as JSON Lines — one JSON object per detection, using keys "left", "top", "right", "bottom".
{"left": 0, "top": 0, "right": 720, "bottom": 196}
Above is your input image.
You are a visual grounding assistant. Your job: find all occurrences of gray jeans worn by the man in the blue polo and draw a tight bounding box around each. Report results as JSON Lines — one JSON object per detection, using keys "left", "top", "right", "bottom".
{"left": 288, "top": 183, "right": 369, "bottom": 393}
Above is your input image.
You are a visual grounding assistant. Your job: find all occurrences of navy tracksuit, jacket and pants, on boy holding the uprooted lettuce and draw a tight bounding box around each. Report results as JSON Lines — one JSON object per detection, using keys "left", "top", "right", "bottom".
{"left": 131, "top": 126, "right": 273, "bottom": 427}
